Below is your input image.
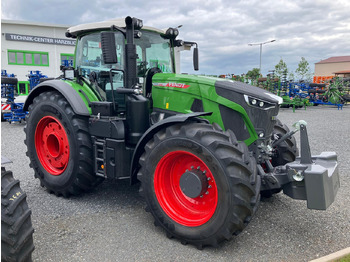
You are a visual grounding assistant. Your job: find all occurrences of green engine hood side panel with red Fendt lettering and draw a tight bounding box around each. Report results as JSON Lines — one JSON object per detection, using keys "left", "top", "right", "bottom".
{"left": 152, "top": 74, "right": 258, "bottom": 145}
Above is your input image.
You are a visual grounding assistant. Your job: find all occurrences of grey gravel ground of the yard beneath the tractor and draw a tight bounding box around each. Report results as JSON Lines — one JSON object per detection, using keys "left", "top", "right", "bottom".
{"left": 1, "top": 106, "right": 350, "bottom": 261}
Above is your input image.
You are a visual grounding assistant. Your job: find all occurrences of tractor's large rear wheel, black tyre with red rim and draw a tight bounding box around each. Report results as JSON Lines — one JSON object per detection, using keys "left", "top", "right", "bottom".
{"left": 24, "top": 91, "right": 101, "bottom": 197}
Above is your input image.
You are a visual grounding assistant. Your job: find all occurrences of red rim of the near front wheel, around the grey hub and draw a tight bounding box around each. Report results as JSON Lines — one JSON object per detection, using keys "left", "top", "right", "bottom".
{"left": 154, "top": 151, "right": 218, "bottom": 227}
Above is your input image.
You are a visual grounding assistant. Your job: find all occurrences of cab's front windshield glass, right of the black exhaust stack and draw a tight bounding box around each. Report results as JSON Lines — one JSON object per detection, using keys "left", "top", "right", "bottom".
{"left": 135, "top": 31, "right": 174, "bottom": 77}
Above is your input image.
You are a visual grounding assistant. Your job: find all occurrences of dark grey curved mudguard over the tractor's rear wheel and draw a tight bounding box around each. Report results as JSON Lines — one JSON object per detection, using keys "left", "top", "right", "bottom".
{"left": 23, "top": 80, "right": 90, "bottom": 116}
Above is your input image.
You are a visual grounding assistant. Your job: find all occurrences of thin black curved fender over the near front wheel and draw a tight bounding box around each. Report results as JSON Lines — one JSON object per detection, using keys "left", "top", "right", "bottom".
{"left": 130, "top": 112, "right": 212, "bottom": 184}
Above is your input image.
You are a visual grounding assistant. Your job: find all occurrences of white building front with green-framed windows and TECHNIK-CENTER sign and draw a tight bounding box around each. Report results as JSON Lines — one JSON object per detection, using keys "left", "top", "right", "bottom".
{"left": 1, "top": 20, "right": 76, "bottom": 81}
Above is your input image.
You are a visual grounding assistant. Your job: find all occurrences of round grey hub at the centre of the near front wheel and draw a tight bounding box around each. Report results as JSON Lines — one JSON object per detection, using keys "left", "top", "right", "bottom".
{"left": 180, "top": 167, "right": 208, "bottom": 198}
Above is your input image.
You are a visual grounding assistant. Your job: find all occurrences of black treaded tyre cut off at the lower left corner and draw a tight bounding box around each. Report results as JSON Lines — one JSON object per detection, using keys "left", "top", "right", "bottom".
{"left": 1, "top": 168, "right": 34, "bottom": 261}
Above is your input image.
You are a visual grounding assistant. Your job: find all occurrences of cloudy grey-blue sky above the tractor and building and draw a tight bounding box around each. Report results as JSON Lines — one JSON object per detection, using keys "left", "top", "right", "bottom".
{"left": 1, "top": 0, "right": 350, "bottom": 75}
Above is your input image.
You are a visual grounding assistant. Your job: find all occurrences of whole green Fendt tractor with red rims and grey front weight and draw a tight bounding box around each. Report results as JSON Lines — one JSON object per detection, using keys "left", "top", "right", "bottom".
{"left": 24, "top": 17, "right": 340, "bottom": 248}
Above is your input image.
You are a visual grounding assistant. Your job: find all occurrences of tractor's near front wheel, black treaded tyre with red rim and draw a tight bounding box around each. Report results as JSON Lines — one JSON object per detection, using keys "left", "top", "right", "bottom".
{"left": 137, "top": 123, "right": 261, "bottom": 249}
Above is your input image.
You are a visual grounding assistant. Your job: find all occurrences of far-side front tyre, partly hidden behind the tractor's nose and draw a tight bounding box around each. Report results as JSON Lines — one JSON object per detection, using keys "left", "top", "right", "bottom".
{"left": 271, "top": 119, "right": 299, "bottom": 166}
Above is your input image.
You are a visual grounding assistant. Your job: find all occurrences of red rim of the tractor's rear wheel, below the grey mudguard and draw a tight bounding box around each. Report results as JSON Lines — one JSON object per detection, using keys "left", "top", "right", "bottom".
{"left": 35, "top": 116, "right": 69, "bottom": 176}
